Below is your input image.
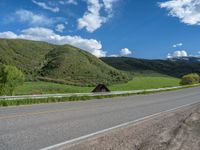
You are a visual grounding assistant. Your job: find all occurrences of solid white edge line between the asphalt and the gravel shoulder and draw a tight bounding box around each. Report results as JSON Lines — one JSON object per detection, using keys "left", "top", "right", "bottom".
{"left": 40, "top": 102, "right": 199, "bottom": 150}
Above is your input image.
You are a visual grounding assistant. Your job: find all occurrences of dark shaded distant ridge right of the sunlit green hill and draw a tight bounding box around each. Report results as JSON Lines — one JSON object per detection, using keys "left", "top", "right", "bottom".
{"left": 101, "top": 57, "right": 200, "bottom": 77}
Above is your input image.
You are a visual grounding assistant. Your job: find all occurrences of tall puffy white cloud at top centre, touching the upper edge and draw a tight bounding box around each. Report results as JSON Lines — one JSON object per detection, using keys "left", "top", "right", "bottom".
{"left": 78, "top": 0, "right": 118, "bottom": 32}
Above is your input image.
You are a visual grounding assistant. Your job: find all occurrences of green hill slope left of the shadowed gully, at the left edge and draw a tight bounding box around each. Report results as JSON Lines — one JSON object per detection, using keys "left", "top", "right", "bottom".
{"left": 0, "top": 39, "right": 54, "bottom": 78}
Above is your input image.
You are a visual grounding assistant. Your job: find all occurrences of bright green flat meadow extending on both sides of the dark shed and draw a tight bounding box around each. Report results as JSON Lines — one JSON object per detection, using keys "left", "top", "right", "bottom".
{"left": 15, "top": 74, "right": 180, "bottom": 95}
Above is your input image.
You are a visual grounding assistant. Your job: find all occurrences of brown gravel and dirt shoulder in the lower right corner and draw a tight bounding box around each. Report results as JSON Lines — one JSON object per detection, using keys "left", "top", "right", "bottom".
{"left": 59, "top": 104, "right": 200, "bottom": 150}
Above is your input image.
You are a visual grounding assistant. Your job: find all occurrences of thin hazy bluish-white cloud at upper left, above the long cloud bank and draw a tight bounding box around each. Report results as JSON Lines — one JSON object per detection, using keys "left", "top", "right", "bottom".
{"left": 15, "top": 9, "right": 53, "bottom": 25}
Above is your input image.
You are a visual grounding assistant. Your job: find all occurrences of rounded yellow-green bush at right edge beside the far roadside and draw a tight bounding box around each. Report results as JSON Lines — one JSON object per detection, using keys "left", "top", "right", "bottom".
{"left": 180, "top": 73, "right": 200, "bottom": 85}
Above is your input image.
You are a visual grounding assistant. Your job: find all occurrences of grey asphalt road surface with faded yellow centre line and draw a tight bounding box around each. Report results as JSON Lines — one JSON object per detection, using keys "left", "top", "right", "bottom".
{"left": 0, "top": 87, "right": 200, "bottom": 150}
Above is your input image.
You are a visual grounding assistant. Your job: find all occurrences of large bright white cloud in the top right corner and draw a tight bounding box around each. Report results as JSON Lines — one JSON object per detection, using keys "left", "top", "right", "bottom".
{"left": 159, "top": 0, "right": 200, "bottom": 25}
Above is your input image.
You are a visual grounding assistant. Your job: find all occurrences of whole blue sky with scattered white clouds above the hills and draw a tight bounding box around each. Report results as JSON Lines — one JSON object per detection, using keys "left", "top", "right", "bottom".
{"left": 0, "top": 0, "right": 200, "bottom": 59}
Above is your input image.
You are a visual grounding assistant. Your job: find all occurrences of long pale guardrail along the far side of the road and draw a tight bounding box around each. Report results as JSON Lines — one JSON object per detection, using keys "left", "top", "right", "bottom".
{"left": 0, "top": 86, "right": 187, "bottom": 100}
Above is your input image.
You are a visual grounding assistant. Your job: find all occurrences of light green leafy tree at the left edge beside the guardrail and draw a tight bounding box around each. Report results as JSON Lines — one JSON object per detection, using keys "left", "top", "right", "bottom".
{"left": 0, "top": 65, "right": 24, "bottom": 95}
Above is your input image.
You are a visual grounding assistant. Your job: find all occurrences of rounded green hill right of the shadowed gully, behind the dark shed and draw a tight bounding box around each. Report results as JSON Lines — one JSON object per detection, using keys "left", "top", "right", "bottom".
{"left": 41, "top": 45, "right": 128, "bottom": 85}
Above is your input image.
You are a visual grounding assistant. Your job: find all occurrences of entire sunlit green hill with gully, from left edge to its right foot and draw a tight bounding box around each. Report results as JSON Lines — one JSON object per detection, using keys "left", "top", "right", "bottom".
{"left": 0, "top": 39, "right": 129, "bottom": 86}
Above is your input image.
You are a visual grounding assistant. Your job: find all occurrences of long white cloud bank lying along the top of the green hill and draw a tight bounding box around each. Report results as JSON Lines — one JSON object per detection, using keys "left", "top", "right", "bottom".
{"left": 0, "top": 27, "right": 106, "bottom": 57}
